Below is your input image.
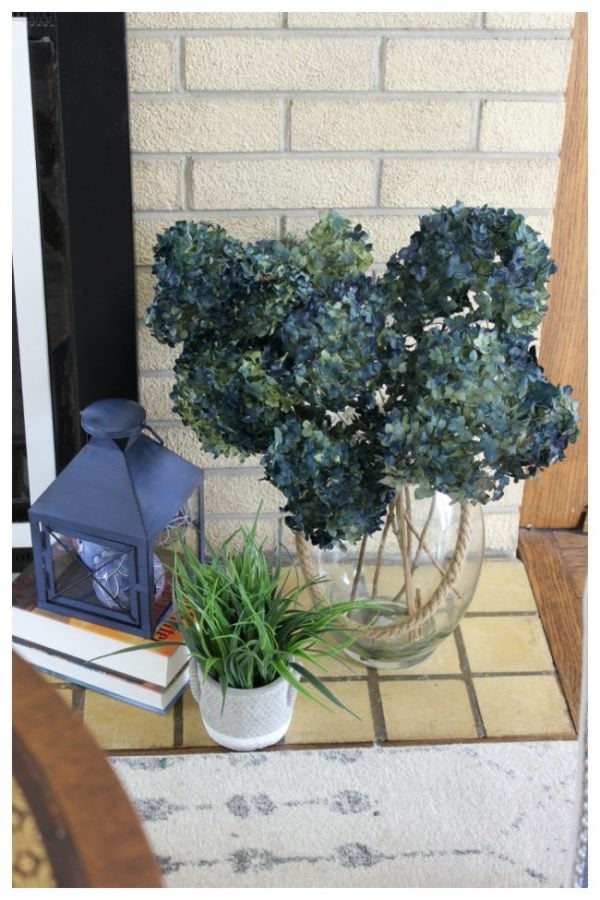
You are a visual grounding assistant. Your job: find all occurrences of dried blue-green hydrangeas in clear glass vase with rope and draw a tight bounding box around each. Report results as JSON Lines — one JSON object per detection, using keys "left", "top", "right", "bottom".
{"left": 147, "top": 203, "right": 578, "bottom": 667}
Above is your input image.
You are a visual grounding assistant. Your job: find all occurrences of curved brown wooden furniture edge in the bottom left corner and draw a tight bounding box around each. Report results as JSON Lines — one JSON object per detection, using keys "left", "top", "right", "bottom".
{"left": 13, "top": 652, "right": 163, "bottom": 888}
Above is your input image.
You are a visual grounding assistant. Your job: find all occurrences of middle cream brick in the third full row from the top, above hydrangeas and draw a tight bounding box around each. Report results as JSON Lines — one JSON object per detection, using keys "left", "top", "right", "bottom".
{"left": 193, "top": 159, "right": 374, "bottom": 209}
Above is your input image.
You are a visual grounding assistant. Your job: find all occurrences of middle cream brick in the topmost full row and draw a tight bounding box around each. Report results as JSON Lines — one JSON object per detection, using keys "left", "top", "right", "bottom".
{"left": 185, "top": 36, "right": 375, "bottom": 91}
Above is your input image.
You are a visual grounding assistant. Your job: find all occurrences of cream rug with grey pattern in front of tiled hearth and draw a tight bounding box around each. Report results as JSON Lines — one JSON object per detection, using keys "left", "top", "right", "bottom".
{"left": 111, "top": 741, "right": 578, "bottom": 888}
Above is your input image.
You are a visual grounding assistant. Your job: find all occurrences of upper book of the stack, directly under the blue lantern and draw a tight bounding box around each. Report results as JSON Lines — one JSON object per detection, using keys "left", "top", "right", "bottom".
{"left": 12, "top": 566, "right": 189, "bottom": 689}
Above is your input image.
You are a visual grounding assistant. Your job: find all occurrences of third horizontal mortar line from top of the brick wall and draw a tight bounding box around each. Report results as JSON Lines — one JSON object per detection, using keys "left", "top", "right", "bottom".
{"left": 131, "top": 149, "right": 560, "bottom": 162}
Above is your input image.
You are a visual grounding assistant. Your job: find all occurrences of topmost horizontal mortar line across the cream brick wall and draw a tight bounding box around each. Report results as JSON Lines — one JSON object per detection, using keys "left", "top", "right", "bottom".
{"left": 126, "top": 25, "right": 572, "bottom": 41}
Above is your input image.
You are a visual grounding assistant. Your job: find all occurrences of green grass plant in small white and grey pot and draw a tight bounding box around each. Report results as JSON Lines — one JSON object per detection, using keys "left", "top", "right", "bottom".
{"left": 104, "top": 517, "right": 370, "bottom": 750}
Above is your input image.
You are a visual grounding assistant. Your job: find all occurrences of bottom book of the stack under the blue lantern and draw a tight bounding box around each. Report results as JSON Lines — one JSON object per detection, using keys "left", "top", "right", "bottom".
{"left": 13, "top": 641, "right": 189, "bottom": 713}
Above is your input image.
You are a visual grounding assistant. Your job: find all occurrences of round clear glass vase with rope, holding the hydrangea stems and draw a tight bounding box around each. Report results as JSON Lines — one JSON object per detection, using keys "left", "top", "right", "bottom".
{"left": 296, "top": 488, "right": 484, "bottom": 669}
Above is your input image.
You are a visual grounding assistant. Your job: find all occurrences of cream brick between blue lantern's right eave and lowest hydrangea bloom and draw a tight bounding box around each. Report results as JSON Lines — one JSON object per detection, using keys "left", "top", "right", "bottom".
{"left": 204, "top": 473, "right": 285, "bottom": 515}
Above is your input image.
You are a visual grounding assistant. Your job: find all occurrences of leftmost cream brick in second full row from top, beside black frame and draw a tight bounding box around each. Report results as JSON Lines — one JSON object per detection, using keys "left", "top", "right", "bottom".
{"left": 130, "top": 99, "right": 280, "bottom": 153}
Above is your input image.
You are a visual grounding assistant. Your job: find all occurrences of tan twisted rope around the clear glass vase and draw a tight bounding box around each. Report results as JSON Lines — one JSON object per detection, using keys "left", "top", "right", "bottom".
{"left": 295, "top": 503, "right": 472, "bottom": 641}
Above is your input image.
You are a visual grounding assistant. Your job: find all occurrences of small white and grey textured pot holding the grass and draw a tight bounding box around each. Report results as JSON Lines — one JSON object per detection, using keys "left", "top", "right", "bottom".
{"left": 190, "top": 659, "right": 297, "bottom": 750}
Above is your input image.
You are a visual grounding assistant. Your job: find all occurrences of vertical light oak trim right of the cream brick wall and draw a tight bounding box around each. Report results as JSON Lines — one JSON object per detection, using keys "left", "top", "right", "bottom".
{"left": 521, "top": 13, "right": 588, "bottom": 528}
